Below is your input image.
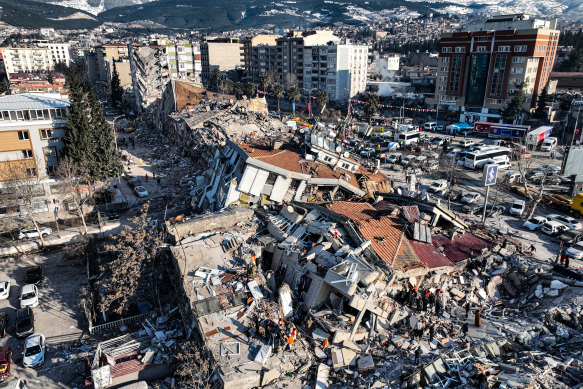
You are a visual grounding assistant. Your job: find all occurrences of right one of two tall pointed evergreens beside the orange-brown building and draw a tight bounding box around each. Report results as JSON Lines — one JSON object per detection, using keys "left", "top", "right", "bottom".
{"left": 88, "top": 87, "right": 123, "bottom": 181}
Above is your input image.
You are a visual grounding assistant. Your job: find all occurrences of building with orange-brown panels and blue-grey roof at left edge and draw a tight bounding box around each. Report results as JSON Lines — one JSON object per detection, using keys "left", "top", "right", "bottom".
{"left": 0, "top": 93, "right": 69, "bottom": 217}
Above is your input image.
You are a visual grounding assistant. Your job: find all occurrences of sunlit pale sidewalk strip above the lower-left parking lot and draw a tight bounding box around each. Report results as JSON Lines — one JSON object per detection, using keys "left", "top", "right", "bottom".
{"left": 0, "top": 221, "right": 121, "bottom": 257}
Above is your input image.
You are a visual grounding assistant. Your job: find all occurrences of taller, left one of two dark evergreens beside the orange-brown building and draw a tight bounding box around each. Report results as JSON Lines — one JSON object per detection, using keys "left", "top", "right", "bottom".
{"left": 63, "top": 67, "right": 94, "bottom": 175}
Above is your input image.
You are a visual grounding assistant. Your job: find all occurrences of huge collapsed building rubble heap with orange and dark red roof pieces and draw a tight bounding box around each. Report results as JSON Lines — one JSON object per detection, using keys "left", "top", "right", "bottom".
{"left": 160, "top": 181, "right": 583, "bottom": 389}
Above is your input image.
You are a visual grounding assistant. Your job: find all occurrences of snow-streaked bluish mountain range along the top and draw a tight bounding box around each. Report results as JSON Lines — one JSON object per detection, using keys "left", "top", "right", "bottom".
{"left": 0, "top": 0, "right": 583, "bottom": 31}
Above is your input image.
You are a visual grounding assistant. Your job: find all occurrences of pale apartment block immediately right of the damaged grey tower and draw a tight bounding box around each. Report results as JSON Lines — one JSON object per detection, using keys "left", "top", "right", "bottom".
{"left": 167, "top": 42, "right": 202, "bottom": 82}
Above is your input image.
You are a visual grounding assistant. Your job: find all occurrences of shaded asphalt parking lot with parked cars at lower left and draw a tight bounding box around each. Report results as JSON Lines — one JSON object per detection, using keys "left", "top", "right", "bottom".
{"left": 0, "top": 251, "right": 87, "bottom": 388}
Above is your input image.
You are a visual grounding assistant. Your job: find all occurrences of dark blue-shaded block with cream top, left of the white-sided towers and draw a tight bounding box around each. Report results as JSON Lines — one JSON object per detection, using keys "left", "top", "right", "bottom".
{"left": 243, "top": 34, "right": 281, "bottom": 83}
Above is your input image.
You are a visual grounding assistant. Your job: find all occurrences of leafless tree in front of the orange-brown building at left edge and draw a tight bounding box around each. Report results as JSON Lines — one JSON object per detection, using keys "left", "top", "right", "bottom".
{"left": 0, "top": 158, "right": 48, "bottom": 247}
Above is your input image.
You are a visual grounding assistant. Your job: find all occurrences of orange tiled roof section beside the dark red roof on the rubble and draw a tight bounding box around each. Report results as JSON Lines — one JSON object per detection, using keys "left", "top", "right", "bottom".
{"left": 328, "top": 201, "right": 420, "bottom": 269}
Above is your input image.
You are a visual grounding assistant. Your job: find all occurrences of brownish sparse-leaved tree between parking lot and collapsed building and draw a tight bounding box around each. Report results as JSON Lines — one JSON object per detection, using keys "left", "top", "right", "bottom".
{"left": 97, "top": 202, "right": 162, "bottom": 315}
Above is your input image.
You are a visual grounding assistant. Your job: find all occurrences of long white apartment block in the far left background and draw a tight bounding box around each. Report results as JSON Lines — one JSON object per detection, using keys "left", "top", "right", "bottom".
{"left": 0, "top": 42, "right": 71, "bottom": 74}
